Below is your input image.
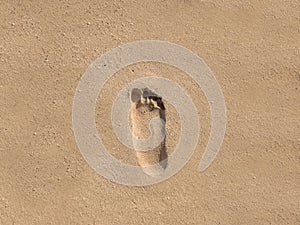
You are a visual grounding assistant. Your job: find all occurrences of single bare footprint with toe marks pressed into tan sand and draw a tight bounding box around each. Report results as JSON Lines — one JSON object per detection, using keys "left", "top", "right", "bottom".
{"left": 130, "top": 88, "right": 168, "bottom": 177}
